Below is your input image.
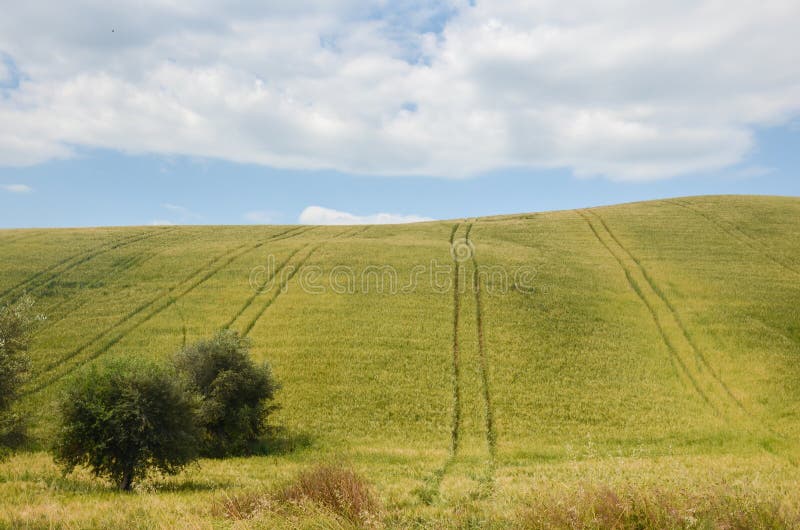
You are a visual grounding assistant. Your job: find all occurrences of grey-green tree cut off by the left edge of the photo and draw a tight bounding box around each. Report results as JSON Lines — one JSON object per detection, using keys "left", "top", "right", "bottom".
{"left": 0, "top": 296, "right": 44, "bottom": 445}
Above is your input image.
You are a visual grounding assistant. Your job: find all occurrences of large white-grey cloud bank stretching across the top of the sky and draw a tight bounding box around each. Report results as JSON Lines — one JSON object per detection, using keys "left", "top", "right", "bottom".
{"left": 0, "top": 0, "right": 800, "bottom": 180}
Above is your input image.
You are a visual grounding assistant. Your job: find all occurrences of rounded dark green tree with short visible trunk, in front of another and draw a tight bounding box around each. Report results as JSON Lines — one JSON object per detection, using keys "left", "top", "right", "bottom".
{"left": 54, "top": 361, "right": 199, "bottom": 491}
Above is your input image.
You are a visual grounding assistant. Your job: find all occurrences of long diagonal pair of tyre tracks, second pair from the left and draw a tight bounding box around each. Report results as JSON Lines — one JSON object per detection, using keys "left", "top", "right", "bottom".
{"left": 21, "top": 223, "right": 313, "bottom": 396}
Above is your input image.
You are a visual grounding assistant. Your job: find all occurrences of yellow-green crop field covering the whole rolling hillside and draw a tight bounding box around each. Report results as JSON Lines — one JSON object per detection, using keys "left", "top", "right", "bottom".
{"left": 0, "top": 196, "right": 800, "bottom": 528}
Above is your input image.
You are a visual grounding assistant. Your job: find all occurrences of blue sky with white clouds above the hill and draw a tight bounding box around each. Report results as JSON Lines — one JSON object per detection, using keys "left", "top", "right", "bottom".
{"left": 0, "top": 0, "right": 800, "bottom": 228}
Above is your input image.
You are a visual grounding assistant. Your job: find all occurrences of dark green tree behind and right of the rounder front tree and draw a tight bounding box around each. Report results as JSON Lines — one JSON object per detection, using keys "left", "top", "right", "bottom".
{"left": 175, "top": 330, "right": 278, "bottom": 457}
